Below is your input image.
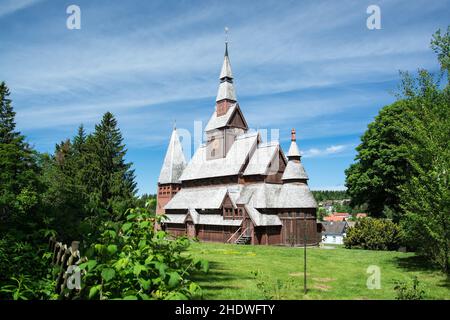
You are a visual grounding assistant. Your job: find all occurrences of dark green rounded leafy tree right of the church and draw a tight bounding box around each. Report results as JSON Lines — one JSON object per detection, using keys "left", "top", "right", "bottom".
{"left": 345, "top": 101, "right": 411, "bottom": 218}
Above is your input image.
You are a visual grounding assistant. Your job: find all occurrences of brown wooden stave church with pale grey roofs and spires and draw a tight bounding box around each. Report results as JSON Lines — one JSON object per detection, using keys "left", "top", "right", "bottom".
{"left": 156, "top": 43, "right": 322, "bottom": 246}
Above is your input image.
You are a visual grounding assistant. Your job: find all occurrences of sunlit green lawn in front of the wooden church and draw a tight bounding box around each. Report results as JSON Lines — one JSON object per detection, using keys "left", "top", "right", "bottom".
{"left": 190, "top": 243, "right": 450, "bottom": 299}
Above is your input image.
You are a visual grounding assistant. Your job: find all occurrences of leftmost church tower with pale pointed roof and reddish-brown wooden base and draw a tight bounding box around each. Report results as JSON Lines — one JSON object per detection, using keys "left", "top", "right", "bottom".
{"left": 156, "top": 128, "right": 186, "bottom": 214}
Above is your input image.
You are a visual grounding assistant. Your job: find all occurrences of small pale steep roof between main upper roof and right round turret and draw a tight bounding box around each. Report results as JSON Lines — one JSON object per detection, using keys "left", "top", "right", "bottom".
{"left": 244, "top": 141, "right": 280, "bottom": 176}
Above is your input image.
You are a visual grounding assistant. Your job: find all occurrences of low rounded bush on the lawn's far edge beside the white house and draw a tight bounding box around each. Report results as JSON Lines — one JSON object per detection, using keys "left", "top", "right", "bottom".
{"left": 344, "top": 218, "right": 401, "bottom": 250}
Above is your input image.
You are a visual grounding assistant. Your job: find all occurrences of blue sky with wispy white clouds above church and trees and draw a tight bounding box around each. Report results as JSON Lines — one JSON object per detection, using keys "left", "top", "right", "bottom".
{"left": 0, "top": 0, "right": 450, "bottom": 193}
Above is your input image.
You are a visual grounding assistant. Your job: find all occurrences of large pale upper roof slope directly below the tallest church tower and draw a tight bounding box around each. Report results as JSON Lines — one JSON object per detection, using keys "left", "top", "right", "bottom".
{"left": 180, "top": 133, "right": 259, "bottom": 181}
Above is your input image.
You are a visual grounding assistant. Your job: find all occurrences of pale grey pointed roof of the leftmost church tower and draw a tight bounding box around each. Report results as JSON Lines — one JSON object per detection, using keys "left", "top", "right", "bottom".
{"left": 158, "top": 125, "right": 186, "bottom": 184}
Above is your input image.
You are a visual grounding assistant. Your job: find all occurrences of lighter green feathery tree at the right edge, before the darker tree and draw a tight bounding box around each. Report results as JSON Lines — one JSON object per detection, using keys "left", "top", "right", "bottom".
{"left": 399, "top": 75, "right": 450, "bottom": 273}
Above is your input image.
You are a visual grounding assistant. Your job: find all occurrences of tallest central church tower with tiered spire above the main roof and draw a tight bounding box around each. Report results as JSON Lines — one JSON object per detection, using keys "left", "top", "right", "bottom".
{"left": 205, "top": 41, "right": 248, "bottom": 160}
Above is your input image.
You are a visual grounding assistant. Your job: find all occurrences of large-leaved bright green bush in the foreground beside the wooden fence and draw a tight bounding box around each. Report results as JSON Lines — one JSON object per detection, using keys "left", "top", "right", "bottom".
{"left": 80, "top": 208, "right": 208, "bottom": 300}
